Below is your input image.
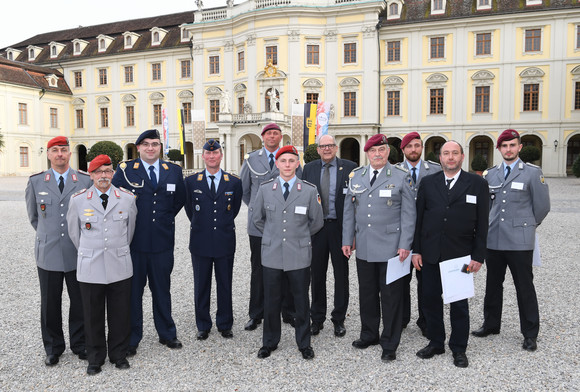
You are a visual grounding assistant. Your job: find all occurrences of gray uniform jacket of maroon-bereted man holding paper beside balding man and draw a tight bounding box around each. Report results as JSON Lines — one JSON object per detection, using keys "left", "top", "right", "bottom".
{"left": 342, "top": 163, "right": 416, "bottom": 262}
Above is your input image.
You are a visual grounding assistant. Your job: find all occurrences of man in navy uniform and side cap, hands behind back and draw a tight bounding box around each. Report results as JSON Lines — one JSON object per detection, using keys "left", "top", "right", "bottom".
{"left": 185, "top": 139, "right": 242, "bottom": 340}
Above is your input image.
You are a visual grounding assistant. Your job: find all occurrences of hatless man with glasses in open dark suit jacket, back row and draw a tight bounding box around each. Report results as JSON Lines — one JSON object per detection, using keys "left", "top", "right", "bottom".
{"left": 302, "top": 135, "right": 356, "bottom": 336}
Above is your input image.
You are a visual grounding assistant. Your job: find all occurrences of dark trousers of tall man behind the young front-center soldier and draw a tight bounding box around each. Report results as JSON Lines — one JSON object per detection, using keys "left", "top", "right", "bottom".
{"left": 248, "top": 235, "right": 294, "bottom": 320}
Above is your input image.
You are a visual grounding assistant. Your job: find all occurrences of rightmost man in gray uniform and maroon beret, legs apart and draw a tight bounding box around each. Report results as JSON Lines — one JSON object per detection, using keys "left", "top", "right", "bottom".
{"left": 472, "top": 129, "right": 550, "bottom": 351}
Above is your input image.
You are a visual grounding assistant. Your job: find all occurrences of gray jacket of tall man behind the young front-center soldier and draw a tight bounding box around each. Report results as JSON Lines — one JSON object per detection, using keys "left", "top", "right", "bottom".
{"left": 240, "top": 148, "right": 302, "bottom": 237}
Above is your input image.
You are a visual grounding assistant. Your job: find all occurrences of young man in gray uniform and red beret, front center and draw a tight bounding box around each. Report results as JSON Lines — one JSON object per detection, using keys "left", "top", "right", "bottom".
{"left": 252, "top": 146, "right": 324, "bottom": 359}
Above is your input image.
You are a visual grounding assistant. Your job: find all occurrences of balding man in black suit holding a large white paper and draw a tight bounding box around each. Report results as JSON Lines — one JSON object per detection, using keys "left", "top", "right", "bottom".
{"left": 413, "top": 141, "right": 489, "bottom": 367}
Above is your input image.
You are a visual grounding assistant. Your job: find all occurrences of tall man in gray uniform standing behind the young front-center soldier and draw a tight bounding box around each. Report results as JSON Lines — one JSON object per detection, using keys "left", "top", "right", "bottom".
{"left": 240, "top": 123, "right": 302, "bottom": 331}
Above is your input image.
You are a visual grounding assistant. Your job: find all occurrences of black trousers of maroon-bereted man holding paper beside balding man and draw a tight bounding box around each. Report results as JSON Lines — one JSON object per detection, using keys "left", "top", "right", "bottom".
{"left": 356, "top": 258, "right": 403, "bottom": 351}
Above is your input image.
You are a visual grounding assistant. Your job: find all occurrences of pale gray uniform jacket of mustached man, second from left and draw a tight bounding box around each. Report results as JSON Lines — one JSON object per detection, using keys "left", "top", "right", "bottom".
{"left": 67, "top": 186, "right": 137, "bottom": 284}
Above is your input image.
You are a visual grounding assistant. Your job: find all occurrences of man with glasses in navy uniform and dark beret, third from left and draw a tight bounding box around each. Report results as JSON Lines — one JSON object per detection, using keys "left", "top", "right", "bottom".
{"left": 113, "top": 129, "right": 185, "bottom": 356}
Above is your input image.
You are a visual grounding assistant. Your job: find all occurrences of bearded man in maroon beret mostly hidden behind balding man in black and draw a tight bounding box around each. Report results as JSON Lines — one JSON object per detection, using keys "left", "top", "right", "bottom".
{"left": 397, "top": 132, "right": 441, "bottom": 336}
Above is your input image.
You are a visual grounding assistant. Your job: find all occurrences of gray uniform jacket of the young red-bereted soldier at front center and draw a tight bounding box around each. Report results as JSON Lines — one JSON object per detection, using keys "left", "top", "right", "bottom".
{"left": 251, "top": 178, "right": 324, "bottom": 271}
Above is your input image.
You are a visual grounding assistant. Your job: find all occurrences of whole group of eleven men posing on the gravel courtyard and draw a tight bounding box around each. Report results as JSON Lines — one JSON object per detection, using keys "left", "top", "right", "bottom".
{"left": 26, "top": 123, "right": 550, "bottom": 375}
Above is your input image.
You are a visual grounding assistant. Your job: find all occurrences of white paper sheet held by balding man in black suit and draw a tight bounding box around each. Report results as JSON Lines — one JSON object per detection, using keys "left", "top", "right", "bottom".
{"left": 439, "top": 255, "right": 475, "bottom": 304}
